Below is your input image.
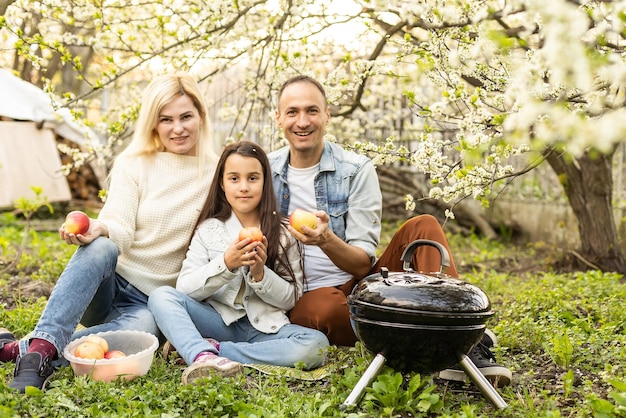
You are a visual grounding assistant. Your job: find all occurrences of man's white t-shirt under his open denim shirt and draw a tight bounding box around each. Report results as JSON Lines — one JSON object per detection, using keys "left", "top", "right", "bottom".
{"left": 287, "top": 163, "right": 352, "bottom": 292}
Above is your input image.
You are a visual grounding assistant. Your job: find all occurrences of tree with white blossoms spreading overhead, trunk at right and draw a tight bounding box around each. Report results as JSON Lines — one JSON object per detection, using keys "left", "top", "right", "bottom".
{"left": 0, "top": 0, "right": 626, "bottom": 272}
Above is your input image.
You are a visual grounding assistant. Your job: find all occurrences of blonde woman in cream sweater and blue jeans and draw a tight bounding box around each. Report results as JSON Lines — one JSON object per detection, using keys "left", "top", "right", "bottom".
{"left": 0, "top": 73, "right": 217, "bottom": 393}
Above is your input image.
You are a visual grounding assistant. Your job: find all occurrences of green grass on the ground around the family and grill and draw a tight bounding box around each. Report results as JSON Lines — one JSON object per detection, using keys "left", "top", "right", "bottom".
{"left": 0, "top": 215, "right": 626, "bottom": 417}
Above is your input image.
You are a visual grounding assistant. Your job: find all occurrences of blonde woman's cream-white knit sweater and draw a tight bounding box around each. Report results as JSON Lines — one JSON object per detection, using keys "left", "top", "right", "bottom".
{"left": 98, "top": 152, "right": 215, "bottom": 295}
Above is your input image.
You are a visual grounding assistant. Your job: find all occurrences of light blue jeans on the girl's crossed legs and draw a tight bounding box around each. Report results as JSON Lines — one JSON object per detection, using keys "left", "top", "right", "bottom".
{"left": 148, "top": 286, "right": 328, "bottom": 369}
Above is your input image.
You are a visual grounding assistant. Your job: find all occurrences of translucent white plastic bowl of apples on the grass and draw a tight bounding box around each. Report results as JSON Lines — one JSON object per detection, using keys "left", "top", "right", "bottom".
{"left": 63, "top": 330, "right": 159, "bottom": 382}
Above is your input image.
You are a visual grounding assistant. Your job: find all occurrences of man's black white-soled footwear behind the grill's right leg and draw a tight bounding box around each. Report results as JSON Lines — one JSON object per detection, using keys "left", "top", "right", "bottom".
{"left": 439, "top": 342, "right": 513, "bottom": 387}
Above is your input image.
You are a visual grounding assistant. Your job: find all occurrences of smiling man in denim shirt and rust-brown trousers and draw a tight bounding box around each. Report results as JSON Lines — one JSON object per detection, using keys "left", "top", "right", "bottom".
{"left": 269, "top": 75, "right": 511, "bottom": 384}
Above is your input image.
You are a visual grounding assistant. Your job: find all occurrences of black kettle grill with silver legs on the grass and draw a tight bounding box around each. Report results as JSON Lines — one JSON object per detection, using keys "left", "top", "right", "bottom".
{"left": 342, "top": 240, "right": 507, "bottom": 409}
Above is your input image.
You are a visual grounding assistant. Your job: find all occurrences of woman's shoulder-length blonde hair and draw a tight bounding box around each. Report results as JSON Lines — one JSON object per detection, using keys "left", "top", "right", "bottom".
{"left": 120, "top": 72, "right": 217, "bottom": 168}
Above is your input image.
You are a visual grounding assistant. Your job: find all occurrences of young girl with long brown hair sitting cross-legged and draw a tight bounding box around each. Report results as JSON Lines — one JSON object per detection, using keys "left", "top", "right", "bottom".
{"left": 148, "top": 141, "right": 328, "bottom": 384}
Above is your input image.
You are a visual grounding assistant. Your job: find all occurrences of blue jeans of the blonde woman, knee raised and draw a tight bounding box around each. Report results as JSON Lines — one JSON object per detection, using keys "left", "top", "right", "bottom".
{"left": 20, "top": 237, "right": 159, "bottom": 357}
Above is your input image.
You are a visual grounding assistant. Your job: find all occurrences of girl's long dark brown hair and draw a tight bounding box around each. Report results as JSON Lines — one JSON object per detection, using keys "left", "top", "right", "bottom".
{"left": 196, "top": 141, "right": 296, "bottom": 281}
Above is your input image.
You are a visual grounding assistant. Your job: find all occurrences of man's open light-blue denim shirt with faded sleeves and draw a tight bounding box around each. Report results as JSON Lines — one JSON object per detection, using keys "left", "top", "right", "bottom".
{"left": 268, "top": 141, "right": 382, "bottom": 262}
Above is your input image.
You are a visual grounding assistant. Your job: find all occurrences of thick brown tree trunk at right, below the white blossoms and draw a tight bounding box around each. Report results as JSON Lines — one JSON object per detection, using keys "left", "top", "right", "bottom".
{"left": 544, "top": 149, "right": 626, "bottom": 273}
